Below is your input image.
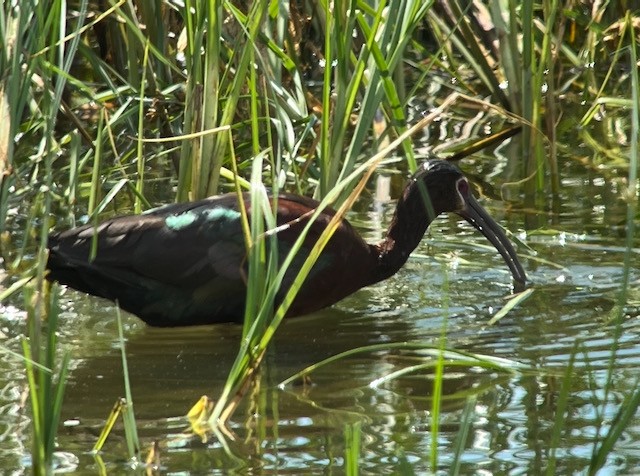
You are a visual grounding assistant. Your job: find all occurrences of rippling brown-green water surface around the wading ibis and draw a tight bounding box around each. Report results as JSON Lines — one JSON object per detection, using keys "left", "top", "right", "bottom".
{"left": 0, "top": 157, "right": 640, "bottom": 474}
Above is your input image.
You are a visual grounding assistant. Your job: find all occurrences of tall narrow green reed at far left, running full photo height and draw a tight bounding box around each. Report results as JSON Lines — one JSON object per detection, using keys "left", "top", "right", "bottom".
{"left": 18, "top": 1, "right": 87, "bottom": 468}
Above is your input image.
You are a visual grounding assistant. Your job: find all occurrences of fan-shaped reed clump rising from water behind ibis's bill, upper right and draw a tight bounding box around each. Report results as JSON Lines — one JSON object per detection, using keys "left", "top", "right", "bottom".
{"left": 420, "top": 0, "right": 606, "bottom": 196}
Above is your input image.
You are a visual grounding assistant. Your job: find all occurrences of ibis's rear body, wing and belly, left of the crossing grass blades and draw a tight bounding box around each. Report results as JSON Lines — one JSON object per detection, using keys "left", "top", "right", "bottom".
{"left": 48, "top": 193, "right": 246, "bottom": 325}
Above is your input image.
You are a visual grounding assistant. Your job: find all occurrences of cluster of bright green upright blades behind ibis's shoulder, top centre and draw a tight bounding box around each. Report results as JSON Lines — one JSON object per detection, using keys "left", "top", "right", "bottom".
{"left": 316, "top": 0, "right": 431, "bottom": 197}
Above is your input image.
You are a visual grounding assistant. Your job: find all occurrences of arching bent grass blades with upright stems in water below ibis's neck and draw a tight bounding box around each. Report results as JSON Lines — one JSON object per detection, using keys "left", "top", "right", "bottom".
{"left": 279, "top": 342, "right": 528, "bottom": 475}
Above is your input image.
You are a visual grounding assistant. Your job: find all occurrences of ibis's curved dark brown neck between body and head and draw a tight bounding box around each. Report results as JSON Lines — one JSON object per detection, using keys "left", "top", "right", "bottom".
{"left": 375, "top": 185, "right": 440, "bottom": 282}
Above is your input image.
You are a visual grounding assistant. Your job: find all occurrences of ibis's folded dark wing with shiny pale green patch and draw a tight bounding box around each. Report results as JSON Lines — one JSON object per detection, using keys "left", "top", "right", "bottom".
{"left": 50, "top": 199, "right": 245, "bottom": 288}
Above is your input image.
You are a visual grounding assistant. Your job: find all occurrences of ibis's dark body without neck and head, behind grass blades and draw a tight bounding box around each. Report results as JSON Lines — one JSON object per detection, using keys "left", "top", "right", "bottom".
{"left": 48, "top": 194, "right": 380, "bottom": 326}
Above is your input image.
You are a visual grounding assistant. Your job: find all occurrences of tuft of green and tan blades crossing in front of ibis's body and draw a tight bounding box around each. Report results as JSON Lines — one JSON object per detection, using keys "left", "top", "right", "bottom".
{"left": 209, "top": 112, "right": 444, "bottom": 433}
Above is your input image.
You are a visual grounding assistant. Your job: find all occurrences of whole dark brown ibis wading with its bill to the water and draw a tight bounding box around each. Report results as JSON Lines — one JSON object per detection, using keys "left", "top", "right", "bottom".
{"left": 48, "top": 160, "right": 526, "bottom": 326}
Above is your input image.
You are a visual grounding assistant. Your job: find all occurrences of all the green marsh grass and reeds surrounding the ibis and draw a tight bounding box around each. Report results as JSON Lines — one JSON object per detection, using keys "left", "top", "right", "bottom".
{"left": 0, "top": 0, "right": 640, "bottom": 474}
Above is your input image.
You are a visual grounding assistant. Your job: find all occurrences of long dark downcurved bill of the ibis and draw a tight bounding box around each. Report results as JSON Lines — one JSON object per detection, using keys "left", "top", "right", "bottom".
{"left": 457, "top": 194, "right": 527, "bottom": 284}
